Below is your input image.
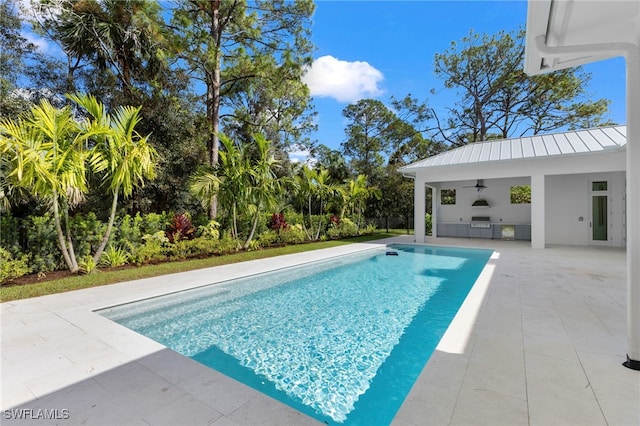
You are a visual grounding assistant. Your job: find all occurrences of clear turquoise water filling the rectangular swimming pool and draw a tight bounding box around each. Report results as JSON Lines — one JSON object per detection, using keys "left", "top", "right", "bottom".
{"left": 100, "top": 245, "right": 491, "bottom": 425}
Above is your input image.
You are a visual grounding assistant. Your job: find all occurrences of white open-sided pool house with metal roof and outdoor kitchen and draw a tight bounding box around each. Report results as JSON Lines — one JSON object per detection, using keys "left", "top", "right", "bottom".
{"left": 400, "top": 126, "right": 626, "bottom": 248}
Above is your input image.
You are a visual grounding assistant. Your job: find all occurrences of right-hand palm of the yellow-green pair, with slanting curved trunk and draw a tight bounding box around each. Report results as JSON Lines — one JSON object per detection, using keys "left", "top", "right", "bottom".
{"left": 68, "top": 95, "right": 157, "bottom": 263}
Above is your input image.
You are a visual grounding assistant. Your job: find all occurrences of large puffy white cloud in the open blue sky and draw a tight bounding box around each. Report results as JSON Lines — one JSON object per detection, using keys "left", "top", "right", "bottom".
{"left": 302, "top": 55, "right": 384, "bottom": 102}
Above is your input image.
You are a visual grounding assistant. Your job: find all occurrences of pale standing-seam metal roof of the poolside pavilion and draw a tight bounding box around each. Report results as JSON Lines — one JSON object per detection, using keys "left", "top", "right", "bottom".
{"left": 401, "top": 126, "right": 627, "bottom": 171}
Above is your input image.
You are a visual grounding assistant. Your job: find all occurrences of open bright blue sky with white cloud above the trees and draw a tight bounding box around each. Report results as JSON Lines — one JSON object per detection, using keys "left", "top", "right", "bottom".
{"left": 298, "top": 0, "right": 626, "bottom": 158}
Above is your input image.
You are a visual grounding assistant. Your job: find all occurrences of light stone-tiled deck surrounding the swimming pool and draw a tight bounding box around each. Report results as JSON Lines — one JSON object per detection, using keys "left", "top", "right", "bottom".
{"left": 0, "top": 236, "right": 640, "bottom": 426}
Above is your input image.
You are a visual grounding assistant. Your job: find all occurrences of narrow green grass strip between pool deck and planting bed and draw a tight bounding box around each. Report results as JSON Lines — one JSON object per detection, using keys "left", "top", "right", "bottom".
{"left": 0, "top": 230, "right": 406, "bottom": 302}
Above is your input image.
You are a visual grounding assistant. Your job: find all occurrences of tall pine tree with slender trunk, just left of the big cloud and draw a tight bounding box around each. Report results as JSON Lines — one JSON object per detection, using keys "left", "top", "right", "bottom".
{"left": 172, "top": 0, "right": 314, "bottom": 219}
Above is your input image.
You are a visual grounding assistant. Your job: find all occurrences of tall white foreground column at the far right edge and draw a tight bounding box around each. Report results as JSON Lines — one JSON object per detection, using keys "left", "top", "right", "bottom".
{"left": 623, "top": 47, "right": 640, "bottom": 370}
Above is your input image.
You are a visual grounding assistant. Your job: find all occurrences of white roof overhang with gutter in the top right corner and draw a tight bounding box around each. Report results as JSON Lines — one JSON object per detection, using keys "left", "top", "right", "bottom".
{"left": 525, "top": 0, "right": 640, "bottom": 75}
